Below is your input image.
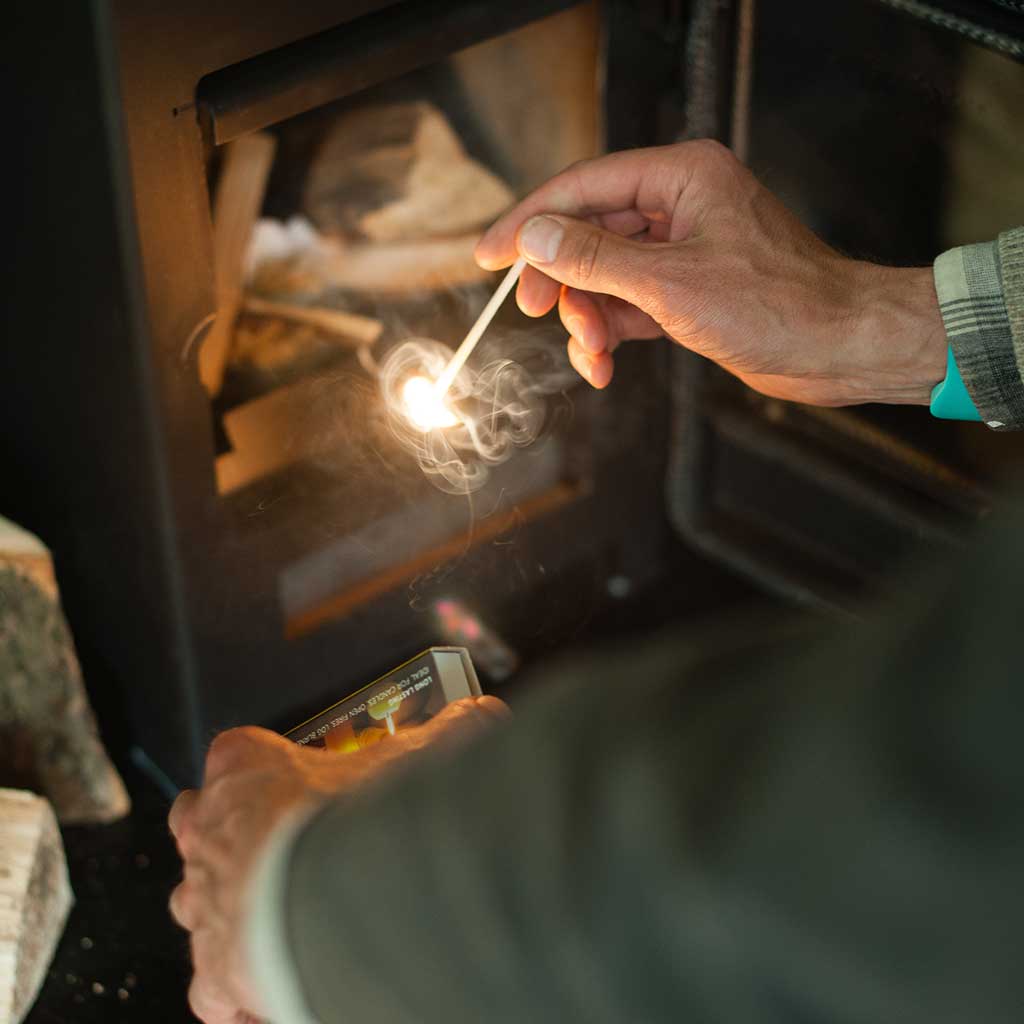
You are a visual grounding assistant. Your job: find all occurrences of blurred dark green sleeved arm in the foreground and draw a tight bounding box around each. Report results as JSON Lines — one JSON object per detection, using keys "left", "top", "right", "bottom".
{"left": 245, "top": 509, "right": 1024, "bottom": 1024}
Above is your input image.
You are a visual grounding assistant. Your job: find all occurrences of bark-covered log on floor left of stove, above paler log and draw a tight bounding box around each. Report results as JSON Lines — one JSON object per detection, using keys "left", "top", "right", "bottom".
{"left": 0, "top": 518, "right": 130, "bottom": 824}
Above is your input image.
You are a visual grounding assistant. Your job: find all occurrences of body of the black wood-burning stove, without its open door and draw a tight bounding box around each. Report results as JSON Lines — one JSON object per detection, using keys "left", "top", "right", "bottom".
{"left": 6, "top": 0, "right": 688, "bottom": 783}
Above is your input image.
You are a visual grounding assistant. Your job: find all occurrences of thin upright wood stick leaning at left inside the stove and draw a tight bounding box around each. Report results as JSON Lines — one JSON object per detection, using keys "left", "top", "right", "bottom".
{"left": 199, "top": 132, "right": 276, "bottom": 395}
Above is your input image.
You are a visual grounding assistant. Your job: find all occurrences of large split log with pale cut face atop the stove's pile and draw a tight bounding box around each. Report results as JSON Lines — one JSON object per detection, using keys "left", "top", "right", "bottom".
{"left": 304, "top": 102, "right": 514, "bottom": 243}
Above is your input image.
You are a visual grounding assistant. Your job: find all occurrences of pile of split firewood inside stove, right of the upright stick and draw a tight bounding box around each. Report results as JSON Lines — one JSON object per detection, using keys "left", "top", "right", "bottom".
{"left": 219, "top": 102, "right": 514, "bottom": 495}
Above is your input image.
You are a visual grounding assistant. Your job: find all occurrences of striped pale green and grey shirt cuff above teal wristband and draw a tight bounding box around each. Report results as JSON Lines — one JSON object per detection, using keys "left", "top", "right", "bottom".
{"left": 935, "top": 242, "right": 1024, "bottom": 430}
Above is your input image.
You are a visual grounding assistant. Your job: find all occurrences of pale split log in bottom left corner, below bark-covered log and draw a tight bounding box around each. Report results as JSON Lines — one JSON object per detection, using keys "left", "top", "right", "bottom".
{"left": 0, "top": 790, "right": 73, "bottom": 1024}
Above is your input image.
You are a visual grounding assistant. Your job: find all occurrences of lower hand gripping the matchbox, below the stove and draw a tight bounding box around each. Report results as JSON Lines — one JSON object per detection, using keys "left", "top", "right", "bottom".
{"left": 169, "top": 696, "right": 509, "bottom": 1024}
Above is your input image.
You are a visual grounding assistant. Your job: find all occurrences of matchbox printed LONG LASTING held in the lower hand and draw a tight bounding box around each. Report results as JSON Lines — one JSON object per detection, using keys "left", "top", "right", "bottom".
{"left": 285, "top": 647, "right": 481, "bottom": 754}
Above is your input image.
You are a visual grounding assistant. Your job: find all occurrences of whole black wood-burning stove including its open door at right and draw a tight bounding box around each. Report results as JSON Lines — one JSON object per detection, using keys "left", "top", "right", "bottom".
{"left": 4, "top": 0, "right": 1024, "bottom": 782}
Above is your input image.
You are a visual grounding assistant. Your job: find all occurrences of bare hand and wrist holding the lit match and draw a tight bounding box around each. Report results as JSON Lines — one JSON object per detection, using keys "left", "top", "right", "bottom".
{"left": 476, "top": 141, "right": 946, "bottom": 406}
